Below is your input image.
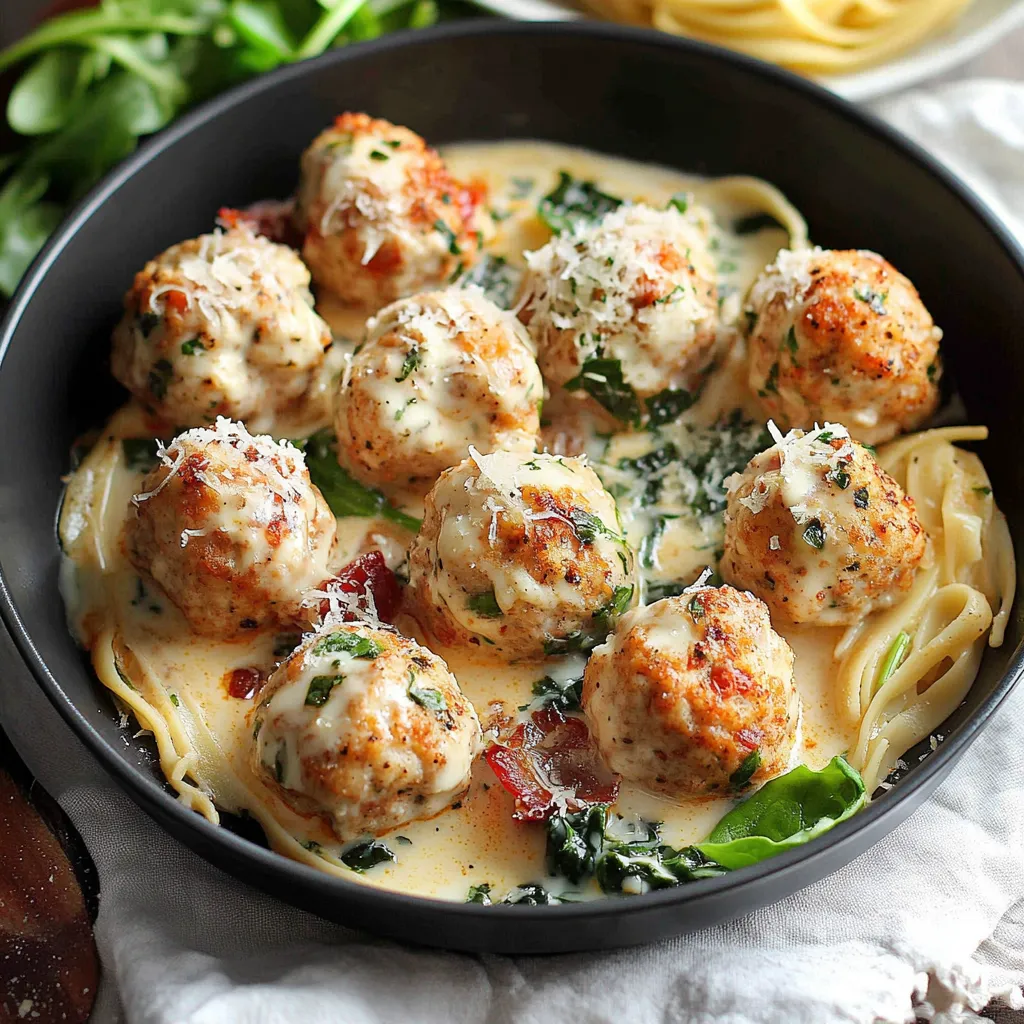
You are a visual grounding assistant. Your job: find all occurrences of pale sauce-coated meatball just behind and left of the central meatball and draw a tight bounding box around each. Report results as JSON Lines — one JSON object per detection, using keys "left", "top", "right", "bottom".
{"left": 335, "top": 289, "right": 544, "bottom": 492}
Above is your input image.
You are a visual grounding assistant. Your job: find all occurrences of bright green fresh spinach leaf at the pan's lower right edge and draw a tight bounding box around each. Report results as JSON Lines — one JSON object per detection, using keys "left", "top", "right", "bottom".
{"left": 697, "top": 757, "right": 865, "bottom": 868}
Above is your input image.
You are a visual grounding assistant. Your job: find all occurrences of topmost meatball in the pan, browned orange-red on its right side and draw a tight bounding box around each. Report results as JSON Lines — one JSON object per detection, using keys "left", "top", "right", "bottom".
{"left": 296, "top": 114, "right": 480, "bottom": 310}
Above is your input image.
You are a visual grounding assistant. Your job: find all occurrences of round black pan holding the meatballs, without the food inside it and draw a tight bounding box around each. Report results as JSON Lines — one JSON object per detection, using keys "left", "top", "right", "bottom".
{"left": 0, "top": 22, "right": 1024, "bottom": 952}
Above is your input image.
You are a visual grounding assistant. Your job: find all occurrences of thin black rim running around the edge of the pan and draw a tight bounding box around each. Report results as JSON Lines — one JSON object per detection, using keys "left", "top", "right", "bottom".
{"left": 0, "top": 18, "right": 1024, "bottom": 923}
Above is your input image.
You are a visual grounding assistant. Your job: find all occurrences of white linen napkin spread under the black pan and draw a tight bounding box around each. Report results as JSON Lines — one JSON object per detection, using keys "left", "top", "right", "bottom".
{"left": 6, "top": 82, "right": 1024, "bottom": 1024}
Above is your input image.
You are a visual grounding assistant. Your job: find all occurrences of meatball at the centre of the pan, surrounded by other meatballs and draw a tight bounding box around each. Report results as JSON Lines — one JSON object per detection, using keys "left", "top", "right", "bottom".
{"left": 410, "top": 452, "right": 636, "bottom": 658}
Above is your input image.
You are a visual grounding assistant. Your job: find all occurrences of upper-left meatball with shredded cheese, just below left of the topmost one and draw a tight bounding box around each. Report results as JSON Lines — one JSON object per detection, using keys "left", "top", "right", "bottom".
{"left": 111, "top": 227, "right": 331, "bottom": 430}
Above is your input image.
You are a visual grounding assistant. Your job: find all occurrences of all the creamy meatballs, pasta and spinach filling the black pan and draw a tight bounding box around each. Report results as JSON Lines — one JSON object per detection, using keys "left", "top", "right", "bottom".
{"left": 59, "top": 123, "right": 1016, "bottom": 904}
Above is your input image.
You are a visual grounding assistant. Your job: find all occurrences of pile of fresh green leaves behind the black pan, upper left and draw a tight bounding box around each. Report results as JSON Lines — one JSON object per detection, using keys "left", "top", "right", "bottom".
{"left": 0, "top": 0, "right": 438, "bottom": 295}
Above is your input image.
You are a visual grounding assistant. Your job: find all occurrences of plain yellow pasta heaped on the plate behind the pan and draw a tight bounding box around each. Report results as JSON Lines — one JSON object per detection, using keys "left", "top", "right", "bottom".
{"left": 585, "top": 0, "right": 971, "bottom": 75}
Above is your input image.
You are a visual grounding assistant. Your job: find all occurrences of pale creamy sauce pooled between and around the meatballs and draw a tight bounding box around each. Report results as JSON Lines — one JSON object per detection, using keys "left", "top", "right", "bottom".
{"left": 60, "top": 142, "right": 853, "bottom": 900}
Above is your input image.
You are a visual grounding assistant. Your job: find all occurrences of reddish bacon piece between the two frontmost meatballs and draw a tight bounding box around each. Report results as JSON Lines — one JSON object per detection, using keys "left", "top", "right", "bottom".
{"left": 484, "top": 709, "right": 618, "bottom": 821}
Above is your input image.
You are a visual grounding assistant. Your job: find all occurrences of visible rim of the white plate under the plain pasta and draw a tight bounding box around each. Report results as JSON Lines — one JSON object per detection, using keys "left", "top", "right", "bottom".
{"left": 475, "top": 0, "right": 1024, "bottom": 100}
